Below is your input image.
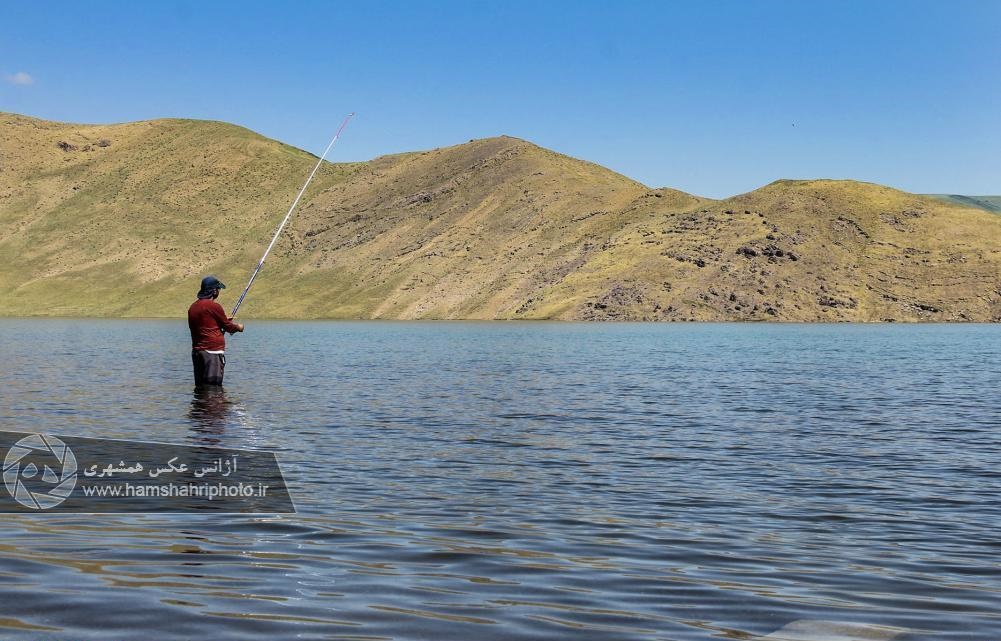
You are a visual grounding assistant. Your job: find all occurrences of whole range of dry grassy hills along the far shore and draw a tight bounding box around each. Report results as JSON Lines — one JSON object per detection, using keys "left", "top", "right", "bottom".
{"left": 0, "top": 114, "right": 1001, "bottom": 321}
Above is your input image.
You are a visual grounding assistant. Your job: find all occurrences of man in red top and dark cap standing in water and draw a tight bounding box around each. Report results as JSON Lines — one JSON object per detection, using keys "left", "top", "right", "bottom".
{"left": 188, "top": 276, "right": 243, "bottom": 386}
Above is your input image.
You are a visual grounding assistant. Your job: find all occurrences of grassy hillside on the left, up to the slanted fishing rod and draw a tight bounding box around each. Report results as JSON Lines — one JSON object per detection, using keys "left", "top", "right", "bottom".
{"left": 0, "top": 114, "right": 353, "bottom": 315}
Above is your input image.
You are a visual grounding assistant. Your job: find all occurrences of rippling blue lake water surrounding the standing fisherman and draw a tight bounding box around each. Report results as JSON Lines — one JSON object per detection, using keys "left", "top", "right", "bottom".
{"left": 0, "top": 319, "right": 1001, "bottom": 641}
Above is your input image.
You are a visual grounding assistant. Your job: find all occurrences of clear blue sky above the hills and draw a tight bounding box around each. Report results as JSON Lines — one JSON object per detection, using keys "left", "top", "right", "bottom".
{"left": 0, "top": 0, "right": 1001, "bottom": 196}
